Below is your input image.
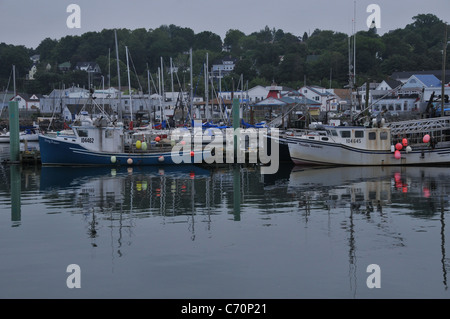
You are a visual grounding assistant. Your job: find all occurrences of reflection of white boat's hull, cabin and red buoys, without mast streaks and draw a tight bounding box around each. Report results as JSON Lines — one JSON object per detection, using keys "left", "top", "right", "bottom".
{"left": 288, "top": 166, "right": 450, "bottom": 212}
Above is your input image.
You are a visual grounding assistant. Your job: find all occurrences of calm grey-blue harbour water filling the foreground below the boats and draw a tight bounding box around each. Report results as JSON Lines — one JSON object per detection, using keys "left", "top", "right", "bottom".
{"left": 0, "top": 142, "right": 450, "bottom": 299}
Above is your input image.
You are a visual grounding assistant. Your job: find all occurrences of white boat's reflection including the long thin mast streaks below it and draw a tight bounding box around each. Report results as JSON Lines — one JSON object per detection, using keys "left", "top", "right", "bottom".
{"left": 287, "top": 166, "right": 450, "bottom": 296}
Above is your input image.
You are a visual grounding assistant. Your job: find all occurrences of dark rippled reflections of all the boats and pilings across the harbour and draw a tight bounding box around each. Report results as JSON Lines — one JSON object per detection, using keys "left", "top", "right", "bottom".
{"left": 0, "top": 165, "right": 450, "bottom": 297}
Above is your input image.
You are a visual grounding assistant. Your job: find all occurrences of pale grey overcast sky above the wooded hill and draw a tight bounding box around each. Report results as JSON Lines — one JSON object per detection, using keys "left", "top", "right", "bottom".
{"left": 0, "top": 0, "right": 450, "bottom": 48}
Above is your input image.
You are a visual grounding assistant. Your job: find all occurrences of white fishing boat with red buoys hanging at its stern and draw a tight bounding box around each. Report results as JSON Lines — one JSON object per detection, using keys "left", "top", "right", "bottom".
{"left": 286, "top": 116, "right": 450, "bottom": 166}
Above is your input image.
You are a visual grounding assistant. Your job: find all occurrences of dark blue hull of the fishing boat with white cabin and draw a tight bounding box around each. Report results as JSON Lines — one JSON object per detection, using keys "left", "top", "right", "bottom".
{"left": 39, "top": 135, "right": 203, "bottom": 166}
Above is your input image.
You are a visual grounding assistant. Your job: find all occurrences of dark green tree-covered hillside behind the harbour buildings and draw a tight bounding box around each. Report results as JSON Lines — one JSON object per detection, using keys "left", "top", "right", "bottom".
{"left": 0, "top": 14, "right": 450, "bottom": 95}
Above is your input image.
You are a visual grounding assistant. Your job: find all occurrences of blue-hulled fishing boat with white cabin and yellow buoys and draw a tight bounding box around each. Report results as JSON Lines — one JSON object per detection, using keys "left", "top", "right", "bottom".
{"left": 39, "top": 93, "right": 210, "bottom": 166}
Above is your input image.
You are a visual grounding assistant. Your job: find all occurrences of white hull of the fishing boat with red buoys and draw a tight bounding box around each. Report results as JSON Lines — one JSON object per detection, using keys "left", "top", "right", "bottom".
{"left": 288, "top": 138, "right": 450, "bottom": 166}
